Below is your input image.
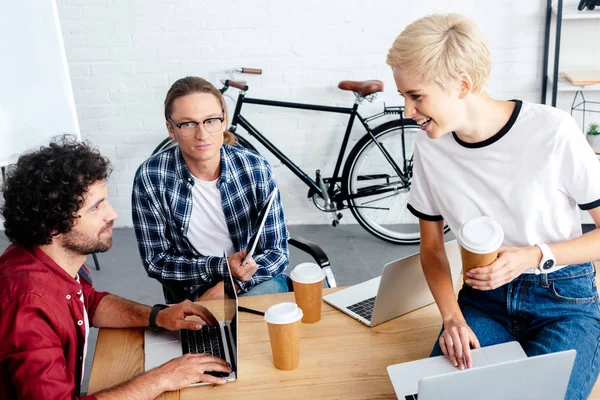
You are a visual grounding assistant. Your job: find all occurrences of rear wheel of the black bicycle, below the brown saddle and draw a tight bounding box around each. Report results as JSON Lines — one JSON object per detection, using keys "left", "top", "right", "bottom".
{"left": 342, "top": 119, "right": 421, "bottom": 244}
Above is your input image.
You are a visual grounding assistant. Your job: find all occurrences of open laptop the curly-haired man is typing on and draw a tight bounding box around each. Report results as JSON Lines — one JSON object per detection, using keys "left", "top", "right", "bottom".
{"left": 144, "top": 254, "right": 238, "bottom": 386}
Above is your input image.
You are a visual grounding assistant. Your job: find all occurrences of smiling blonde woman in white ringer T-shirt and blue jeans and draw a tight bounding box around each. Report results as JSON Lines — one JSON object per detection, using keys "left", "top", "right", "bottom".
{"left": 387, "top": 14, "right": 600, "bottom": 399}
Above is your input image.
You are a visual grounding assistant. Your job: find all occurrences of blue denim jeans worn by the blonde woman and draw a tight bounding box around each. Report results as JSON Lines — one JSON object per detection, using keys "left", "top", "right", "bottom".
{"left": 431, "top": 263, "right": 600, "bottom": 400}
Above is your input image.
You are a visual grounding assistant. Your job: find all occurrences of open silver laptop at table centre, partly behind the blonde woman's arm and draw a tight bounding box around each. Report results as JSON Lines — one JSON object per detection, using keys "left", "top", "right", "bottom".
{"left": 323, "top": 240, "right": 462, "bottom": 327}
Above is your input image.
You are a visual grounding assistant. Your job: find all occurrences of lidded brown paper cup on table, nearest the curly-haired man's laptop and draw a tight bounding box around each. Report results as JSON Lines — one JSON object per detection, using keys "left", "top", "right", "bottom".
{"left": 265, "top": 302, "right": 302, "bottom": 371}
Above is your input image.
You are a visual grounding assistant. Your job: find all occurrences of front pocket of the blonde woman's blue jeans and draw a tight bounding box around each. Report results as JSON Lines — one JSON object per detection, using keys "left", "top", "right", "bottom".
{"left": 549, "top": 266, "right": 598, "bottom": 304}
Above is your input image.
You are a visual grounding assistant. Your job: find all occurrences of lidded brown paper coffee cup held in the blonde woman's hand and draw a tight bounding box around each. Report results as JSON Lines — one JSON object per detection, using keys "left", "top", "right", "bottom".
{"left": 457, "top": 217, "right": 504, "bottom": 280}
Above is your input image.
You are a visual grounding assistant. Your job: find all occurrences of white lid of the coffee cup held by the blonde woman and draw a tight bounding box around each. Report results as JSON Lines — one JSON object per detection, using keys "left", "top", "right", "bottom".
{"left": 457, "top": 217, "right": 504, "bottom": 254}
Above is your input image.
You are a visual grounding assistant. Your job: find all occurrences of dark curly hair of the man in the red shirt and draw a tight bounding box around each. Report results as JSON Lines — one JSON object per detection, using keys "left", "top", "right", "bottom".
{"left": 2, "top": 136, "right": 111, "bottom": 248}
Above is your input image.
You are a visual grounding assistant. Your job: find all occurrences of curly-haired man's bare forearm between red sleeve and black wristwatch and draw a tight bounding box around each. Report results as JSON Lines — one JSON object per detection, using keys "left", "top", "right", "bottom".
{"left": 92, "top": 294, "right": 152, "bottom": 328}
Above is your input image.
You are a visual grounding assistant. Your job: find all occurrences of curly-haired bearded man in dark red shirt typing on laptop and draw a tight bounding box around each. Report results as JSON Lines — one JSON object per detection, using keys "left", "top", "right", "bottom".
{"left": 0, "top": 138, "right": 230, "bottom": 399}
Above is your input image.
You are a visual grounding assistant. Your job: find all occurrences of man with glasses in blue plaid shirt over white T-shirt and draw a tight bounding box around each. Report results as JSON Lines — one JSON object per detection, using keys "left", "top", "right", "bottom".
{"left": 132, "top": 77, "right": 290, "bottom": 303}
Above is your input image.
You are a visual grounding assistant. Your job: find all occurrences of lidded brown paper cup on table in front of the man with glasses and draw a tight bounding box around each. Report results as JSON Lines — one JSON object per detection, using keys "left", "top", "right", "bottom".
{"left": 290, "top": 263, "right": 325, "bottom": 324}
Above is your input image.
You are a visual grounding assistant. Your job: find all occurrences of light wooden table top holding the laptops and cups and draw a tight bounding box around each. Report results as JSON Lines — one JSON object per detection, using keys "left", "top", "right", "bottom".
{"left": 89, "top": 289, "right": 600, "bottom": 400}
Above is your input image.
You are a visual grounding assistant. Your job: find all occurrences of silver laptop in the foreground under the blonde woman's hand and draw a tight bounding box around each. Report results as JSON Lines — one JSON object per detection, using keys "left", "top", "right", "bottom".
{"left": 387, "top": 342, "right": 576, "bottom": 400}
